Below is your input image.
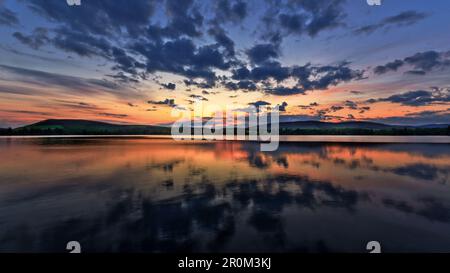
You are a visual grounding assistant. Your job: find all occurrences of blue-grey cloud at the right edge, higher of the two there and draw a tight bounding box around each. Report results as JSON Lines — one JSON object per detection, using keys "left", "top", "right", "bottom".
{"left": 374, "top": 51, "right": 450, "bottom": 75}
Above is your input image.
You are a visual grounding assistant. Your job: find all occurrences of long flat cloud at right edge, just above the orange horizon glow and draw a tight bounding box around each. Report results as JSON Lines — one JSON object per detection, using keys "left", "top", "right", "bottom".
{"left": 367, "top": 87, "right": 450, "bottom": 107}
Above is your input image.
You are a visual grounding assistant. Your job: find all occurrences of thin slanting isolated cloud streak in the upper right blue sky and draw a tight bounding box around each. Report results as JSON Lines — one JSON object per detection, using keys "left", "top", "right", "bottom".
{"left": 353, "top": 10, "right": 427, "bottom": 35}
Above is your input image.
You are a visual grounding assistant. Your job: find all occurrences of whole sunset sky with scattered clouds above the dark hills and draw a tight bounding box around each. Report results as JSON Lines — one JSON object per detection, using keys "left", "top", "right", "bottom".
{"left": 0, "top": 0, "right": 450, "bottom": 127}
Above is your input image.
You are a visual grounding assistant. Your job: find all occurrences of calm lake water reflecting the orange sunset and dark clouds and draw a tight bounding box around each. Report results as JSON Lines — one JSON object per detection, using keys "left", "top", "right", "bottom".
{"left": 0, "top": 137, "right": 450, "bottom": 252}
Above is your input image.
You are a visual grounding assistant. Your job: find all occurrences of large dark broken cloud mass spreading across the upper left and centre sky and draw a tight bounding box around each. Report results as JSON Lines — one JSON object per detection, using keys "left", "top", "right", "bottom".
{"left": 14, "top": 0, "right": 362, "bottom": 95}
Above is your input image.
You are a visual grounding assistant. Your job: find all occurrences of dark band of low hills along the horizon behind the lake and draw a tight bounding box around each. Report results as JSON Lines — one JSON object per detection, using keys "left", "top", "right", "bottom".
{"left": 0, "top": 119, "right": 450, "bottom": 135}
